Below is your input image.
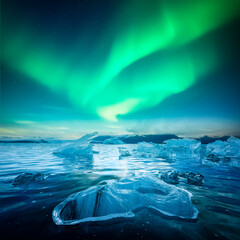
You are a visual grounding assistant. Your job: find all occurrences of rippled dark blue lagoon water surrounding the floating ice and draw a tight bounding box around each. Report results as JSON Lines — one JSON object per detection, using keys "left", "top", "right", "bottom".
{"left": 0, "top": 143, "right": 240, "bottom": 240}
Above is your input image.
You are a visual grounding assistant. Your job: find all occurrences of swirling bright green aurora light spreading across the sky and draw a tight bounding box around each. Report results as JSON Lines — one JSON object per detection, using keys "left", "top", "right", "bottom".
{"left": 2, "top": 0, "right": 240, "bottom": 121}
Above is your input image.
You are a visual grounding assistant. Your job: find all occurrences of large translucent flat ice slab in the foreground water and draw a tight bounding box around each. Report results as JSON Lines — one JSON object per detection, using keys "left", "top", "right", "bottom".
{"left": 52, "top": 174, "right": 198, "bottom": 225}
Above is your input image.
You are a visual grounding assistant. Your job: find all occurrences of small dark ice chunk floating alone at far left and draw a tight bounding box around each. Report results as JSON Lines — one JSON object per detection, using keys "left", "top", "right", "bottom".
{"left": 12, "top": 173, "right": 45, "bottom": 186}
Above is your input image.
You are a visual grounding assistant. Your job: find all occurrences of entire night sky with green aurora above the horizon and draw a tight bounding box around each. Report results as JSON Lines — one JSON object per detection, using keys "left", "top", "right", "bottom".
{"left": 0, "top": 0, "right": 240, "bottom": 138}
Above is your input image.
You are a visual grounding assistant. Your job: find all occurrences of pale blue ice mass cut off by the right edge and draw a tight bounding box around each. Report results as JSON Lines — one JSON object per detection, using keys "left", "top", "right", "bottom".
{"left": 203, "top": 137, "right": 240, "bottom": 167}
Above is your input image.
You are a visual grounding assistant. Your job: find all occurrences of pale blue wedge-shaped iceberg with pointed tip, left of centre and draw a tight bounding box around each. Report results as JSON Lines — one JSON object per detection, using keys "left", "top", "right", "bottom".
{"left": 53, "top": 132, "right": 97, "bottom": 159}
